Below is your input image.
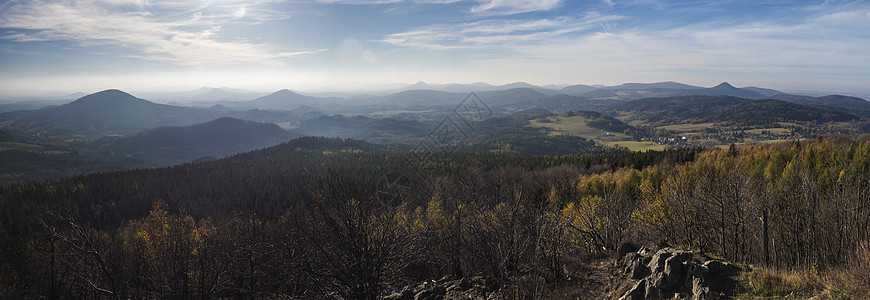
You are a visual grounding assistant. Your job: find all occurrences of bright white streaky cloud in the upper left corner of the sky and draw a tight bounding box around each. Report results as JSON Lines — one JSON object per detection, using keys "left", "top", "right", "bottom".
{"left": 0, "top": 0, "right": 318, "bottom": 65}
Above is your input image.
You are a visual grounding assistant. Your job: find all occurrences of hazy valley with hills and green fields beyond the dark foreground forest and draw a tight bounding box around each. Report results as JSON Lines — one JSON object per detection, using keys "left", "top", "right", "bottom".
{"left": 0, "top": 82, "right": 870, "bottom": 183}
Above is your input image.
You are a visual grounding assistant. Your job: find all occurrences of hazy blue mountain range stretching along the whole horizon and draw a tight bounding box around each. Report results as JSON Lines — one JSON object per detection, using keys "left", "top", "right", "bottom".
{"left": 0, "top": 82, "right": 870, "bottom": 142}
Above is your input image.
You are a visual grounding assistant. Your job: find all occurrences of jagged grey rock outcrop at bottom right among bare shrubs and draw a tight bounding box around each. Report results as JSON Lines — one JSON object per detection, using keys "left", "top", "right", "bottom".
{"left": 620, "top": 248, "right": 740, "bottom": 300}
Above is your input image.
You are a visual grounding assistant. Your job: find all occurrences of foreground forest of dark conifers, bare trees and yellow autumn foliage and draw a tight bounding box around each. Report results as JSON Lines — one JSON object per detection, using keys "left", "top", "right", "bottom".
{"left": 0, "top": 136, "right": 870, "bottom": 299}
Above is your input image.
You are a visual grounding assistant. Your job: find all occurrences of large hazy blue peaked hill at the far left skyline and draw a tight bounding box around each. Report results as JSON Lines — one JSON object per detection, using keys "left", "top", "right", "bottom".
{"left": 0, "top": 90, "right": 219, "bottom": 136}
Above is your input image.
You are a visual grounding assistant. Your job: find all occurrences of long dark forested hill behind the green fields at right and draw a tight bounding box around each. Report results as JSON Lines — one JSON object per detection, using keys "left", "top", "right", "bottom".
{"left": 605, "top": 96, "right": 862, "bottom": 125}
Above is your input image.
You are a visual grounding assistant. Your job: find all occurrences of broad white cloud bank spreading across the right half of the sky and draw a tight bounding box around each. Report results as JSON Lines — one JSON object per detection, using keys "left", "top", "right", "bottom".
{"left": 381, "top": 1, "right": 870, "bottom": 86}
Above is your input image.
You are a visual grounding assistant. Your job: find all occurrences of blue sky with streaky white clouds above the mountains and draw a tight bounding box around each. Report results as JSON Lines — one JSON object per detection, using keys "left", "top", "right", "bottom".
{"left": 0, "top": 0, "right": 870, "bottom": 94}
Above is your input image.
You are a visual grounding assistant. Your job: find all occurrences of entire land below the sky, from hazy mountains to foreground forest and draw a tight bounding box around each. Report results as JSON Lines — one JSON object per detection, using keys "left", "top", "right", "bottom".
{"left": 0, "top": 82, "right": 870, "bottom": 299}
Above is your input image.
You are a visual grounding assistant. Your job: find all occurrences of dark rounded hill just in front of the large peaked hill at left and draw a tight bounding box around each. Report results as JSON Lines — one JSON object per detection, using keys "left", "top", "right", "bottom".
{"left": 95, "top": 117, "right": 292, "bottom": 165}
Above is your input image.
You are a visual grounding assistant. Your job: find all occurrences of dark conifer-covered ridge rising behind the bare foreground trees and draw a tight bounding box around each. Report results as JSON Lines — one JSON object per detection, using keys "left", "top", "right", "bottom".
{"left": 0, "top": 137, "right": 700, "bottom": 226}
